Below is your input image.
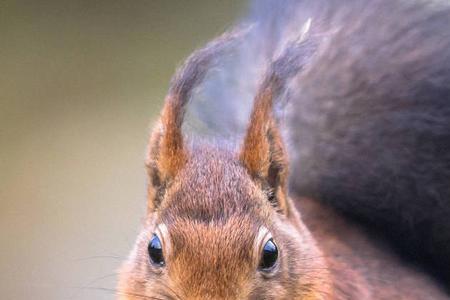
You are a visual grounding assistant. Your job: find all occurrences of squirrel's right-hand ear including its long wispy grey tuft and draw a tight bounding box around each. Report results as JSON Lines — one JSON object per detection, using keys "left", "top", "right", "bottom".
{"left": 239, "top": 39, "right": 316, "bottom": 214}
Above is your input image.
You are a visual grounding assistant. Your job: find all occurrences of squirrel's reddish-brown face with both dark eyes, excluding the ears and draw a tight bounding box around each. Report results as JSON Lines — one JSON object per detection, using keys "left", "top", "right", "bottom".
{"left": 119, "top": 147, "right": 327, "bottom": 299}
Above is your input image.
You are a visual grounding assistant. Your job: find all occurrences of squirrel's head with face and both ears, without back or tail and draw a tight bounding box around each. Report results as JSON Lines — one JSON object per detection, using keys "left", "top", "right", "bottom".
{"left": 118, "top": 29, "right": 329, "bottom": 300}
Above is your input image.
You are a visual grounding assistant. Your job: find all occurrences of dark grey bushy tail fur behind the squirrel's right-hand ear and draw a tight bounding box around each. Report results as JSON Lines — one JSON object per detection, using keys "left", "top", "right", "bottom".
{"left": 272, "top": 1, "right": 450, "bottom": 278}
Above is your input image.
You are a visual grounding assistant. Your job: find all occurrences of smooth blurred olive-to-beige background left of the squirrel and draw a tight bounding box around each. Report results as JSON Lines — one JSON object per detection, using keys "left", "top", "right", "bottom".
{"left": 0, "top": 0, "right": 246, "bottom": 300}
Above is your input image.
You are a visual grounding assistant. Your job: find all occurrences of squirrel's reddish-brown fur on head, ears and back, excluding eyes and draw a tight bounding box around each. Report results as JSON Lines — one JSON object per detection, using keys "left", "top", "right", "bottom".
{"left": 118, "top": 10, "right": 447, "bottom": 300}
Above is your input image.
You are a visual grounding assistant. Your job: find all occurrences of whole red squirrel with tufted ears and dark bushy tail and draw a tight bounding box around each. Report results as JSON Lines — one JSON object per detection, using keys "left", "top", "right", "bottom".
{"left": 117, "top": 0, "right": 450, "bottom": 300}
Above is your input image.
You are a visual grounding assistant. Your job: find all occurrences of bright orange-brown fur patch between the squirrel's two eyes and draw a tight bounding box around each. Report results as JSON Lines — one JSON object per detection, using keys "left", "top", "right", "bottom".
{"left": 163, "top": 217, "right": 258, "bottom": 299}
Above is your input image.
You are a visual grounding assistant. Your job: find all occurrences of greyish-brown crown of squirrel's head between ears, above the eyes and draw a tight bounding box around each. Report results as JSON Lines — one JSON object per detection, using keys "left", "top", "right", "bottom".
{"left": 160, "top": 148, "right": 270, "bottom": 223}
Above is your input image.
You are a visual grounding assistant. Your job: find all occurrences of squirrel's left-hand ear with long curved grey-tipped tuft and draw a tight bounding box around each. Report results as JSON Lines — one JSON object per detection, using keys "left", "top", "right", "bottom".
{"left": 146, "top": 30, "right": 246, "bottom": 211}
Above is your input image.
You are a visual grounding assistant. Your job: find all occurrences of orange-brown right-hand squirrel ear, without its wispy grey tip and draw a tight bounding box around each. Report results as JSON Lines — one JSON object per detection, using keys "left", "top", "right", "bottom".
{"left": 239, "top": 78, "right": 289, "bottom": 214}
